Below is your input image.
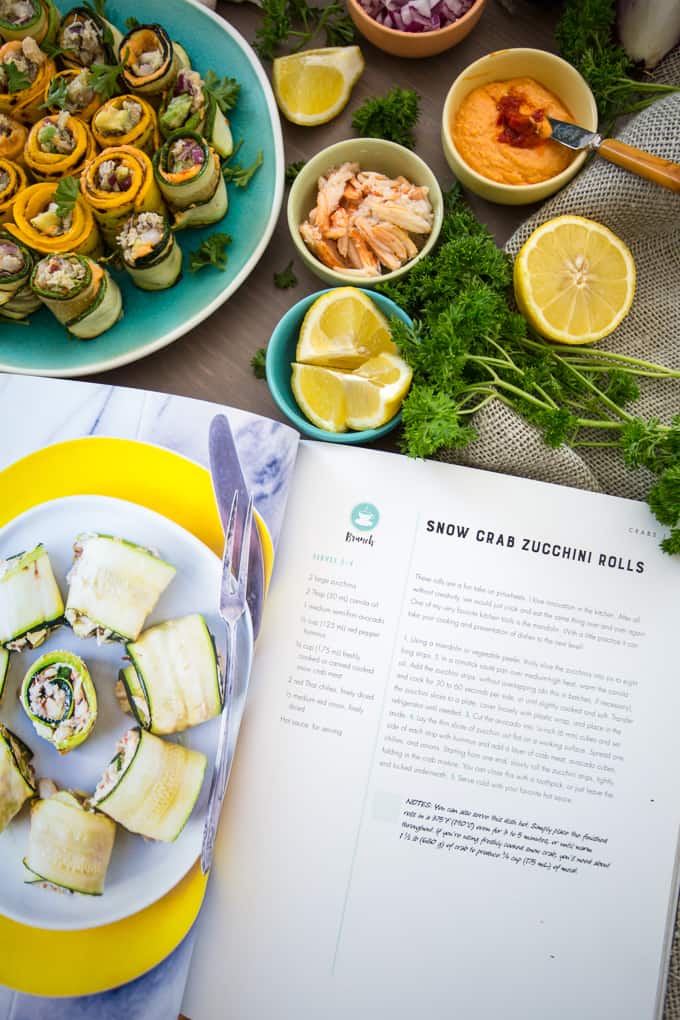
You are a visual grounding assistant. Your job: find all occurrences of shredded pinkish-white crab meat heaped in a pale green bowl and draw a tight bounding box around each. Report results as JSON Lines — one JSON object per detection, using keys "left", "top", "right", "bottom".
{"left": 300, "top": 162, "right": 434, "bottom": 276}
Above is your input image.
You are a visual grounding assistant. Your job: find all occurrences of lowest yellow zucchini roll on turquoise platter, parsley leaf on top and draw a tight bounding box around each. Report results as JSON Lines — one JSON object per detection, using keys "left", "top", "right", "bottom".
{"left": 5, "top": 183, "right": 103, "bottom": 258}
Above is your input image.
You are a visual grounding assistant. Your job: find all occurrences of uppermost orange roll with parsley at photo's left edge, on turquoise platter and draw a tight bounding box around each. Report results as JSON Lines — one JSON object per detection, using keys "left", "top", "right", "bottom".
{"left": 0, "top": 36, "right": 56, "bottom": 123}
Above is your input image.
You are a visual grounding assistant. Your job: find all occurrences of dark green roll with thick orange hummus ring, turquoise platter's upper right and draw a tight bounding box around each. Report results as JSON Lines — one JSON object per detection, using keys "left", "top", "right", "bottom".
{"left": 118, "top": 24, "right": 190, "bottom": 102}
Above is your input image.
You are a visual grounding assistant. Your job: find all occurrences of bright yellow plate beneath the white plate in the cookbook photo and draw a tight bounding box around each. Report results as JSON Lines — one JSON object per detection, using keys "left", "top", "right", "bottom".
{"left": 0, "top": 437, "right": 273, "bottom": 996}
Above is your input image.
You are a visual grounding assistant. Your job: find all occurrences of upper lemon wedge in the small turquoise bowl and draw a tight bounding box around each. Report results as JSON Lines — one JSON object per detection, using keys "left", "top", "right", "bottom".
{"left": 296, "top": 287, "right": 398, "bottom": 368}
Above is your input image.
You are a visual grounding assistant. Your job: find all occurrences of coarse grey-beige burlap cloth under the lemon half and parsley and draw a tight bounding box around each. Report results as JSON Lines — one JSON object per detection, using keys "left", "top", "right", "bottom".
{"left": 441, "top": 48, "right": 680, "bottom": 1020}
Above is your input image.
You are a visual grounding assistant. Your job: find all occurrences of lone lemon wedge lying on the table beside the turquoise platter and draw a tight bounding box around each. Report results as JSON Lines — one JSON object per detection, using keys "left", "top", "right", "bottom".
{"left": 272, "top": 46, "right": 364, "bottom": 126}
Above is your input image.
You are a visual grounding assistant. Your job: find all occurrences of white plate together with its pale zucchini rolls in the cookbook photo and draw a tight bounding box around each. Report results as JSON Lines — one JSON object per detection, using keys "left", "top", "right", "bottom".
{"left": 0, "top": 496, "right": 251, "bottom": 929}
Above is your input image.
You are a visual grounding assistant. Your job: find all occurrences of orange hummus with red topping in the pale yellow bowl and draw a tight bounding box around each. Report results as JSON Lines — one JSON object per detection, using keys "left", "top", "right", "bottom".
{"left": 451, "top": 78, "right": 575, "bottom": 185}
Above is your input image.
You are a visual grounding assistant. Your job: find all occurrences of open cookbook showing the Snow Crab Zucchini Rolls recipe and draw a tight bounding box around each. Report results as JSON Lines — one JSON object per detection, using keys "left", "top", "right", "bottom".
{"left": 0, "top": 376, "right": 680, "bottom": 1020}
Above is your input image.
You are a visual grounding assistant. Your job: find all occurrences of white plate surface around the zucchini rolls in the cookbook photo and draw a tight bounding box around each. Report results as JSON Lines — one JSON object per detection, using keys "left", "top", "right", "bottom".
{"left": 0, "top": 496, "right": 251, "bottom": 930}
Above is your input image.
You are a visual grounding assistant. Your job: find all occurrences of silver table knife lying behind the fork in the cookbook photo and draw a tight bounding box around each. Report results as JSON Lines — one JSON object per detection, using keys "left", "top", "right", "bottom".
{"left": 208, "top": 414, "right": 264, "bottom": 640}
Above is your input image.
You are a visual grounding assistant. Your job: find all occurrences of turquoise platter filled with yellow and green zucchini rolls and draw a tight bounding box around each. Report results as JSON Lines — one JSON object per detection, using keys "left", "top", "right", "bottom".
{"left": 0, "top": 0, "right": 283, "bottom": 375}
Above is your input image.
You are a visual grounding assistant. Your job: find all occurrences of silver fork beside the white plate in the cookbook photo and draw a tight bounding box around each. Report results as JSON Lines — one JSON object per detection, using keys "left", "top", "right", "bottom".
{"left": 201, "top": 491, "right": 253, "bottom": 875}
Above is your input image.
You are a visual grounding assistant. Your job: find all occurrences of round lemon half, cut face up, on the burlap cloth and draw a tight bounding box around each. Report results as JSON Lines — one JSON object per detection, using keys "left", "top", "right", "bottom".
{"left": 514, "top": 216, "right": 635, "bottom": 344}
